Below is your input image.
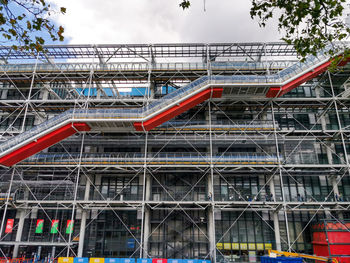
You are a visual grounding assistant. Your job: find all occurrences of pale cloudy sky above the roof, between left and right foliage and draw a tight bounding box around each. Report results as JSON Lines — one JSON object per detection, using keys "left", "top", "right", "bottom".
{"left": 54, "top": 0, "right": 280, "bottom": 44}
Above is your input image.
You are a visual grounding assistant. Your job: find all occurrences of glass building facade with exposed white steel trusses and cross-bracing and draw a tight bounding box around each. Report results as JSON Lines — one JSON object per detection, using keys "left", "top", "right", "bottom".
{"left": 0, "top": 43, "right": 350, "bottom": 262}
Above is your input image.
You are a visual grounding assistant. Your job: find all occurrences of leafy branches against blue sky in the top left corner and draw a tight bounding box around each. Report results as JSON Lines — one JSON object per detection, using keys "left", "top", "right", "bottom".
{"left": 0, "top": 0, "right": 66, "bottom": 52}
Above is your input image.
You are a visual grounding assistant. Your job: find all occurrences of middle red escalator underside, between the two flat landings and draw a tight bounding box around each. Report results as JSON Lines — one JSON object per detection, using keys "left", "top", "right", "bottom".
{"left": 134, "top": 88, "right": 223, "bottom": 131}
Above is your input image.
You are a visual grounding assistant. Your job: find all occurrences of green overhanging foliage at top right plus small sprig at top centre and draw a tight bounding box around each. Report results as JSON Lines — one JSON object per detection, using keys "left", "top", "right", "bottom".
{"left": 180, "top": 0, "right": 350, "bottom": 57}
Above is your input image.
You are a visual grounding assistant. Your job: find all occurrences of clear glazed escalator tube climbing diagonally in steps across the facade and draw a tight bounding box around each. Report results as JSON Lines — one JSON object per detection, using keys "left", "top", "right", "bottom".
{"left": 0, "top": 43, "right": 344, "bottom": 155}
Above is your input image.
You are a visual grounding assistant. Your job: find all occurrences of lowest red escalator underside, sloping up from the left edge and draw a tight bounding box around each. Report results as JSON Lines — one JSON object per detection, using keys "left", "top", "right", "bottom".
{"left": 0, "top": 122, "right": 90, "bottom": 166}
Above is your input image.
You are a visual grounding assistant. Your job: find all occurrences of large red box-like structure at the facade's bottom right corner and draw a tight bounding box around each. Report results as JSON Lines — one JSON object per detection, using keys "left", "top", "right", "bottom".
{"left": 312, "top": 221, "right": 350, "bottom": 263}
